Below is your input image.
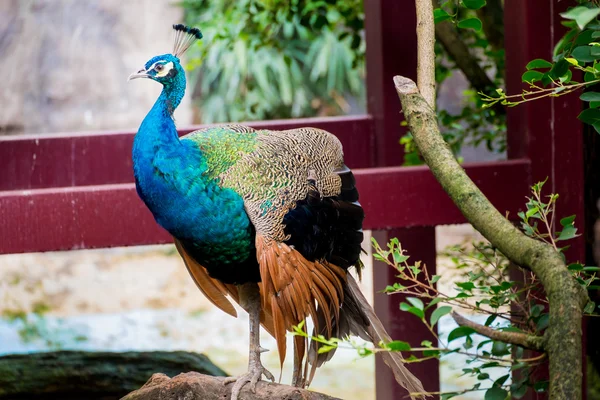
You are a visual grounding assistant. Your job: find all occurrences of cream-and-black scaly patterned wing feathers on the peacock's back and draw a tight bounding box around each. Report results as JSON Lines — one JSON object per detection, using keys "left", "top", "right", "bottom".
{"left": 220, "top": 128, "right": 344, "bottom": 241}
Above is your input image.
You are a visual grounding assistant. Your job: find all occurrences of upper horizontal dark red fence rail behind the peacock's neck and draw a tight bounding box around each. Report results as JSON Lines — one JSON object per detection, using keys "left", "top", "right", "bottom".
{"left": 0, "top": 115, "right": 373, "bottom": 191}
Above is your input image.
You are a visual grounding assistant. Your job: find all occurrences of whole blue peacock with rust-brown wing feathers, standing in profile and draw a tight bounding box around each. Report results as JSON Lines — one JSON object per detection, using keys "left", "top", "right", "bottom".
{"left": 129, "top": 24, "right": 424, "bottom": 400}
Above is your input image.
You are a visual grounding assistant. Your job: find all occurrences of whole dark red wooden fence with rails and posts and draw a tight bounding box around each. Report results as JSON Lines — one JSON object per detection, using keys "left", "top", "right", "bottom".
{"left": 0, "top": 0, "right": 583, "bottom": 400}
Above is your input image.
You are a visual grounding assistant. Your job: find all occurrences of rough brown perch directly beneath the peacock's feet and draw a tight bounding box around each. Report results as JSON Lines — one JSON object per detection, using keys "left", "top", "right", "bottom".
{"left": 121, "top": 372, "right": 340, "bottom": 400}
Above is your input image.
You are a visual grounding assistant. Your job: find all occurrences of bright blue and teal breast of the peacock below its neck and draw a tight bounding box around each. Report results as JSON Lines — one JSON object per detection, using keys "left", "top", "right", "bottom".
{"left": 133, "top": 117, "right": 254, "bottom": 264}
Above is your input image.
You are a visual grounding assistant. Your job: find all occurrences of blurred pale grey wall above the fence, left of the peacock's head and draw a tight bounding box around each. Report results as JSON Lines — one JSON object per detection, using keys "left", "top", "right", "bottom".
{"left": 0, "top": 0, "right": 191, "bottom": 134}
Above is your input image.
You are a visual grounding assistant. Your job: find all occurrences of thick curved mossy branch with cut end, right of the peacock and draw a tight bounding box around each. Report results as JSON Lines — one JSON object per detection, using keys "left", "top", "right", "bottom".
{"left": 394, "top": 73, "right": 588, "bottom": 400}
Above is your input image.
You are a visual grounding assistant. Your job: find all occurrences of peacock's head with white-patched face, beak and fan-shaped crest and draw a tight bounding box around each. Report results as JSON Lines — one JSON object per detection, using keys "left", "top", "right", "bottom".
{"left": 128, "top": 24, "right": 202, "bottom": 86}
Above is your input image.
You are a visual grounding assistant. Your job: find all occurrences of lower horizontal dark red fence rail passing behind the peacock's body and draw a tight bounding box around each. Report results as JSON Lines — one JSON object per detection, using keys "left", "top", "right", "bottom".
{"left": 0, "top": 160, "right": 529, "bottom": 254}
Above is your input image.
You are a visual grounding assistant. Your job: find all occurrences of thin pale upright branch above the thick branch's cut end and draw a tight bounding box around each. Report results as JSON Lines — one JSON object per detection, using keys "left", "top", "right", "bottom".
{"left": 416, "top": 1, "right": 436, "bottom": 109}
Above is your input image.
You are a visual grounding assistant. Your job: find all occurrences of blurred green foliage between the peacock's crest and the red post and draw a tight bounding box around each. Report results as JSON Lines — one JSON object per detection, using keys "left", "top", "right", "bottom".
{"left": 181, "top": 0, "right": 365, "bottom": 123}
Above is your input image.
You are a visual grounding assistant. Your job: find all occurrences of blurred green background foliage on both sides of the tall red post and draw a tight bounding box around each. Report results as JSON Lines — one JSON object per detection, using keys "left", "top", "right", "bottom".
{"left": 180, "top": 0, "right": 506, "bottom": 165}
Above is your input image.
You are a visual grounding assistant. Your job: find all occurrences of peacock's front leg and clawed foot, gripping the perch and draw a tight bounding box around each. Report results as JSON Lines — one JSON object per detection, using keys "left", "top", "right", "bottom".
{"left": 225, "top": 283, "right": 275, "bottom": 400}
